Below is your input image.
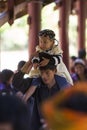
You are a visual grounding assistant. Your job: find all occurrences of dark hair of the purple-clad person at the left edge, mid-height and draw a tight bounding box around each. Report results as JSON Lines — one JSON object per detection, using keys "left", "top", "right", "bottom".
{"left": 1, "top": 69, "right": 14, "bottom": 83}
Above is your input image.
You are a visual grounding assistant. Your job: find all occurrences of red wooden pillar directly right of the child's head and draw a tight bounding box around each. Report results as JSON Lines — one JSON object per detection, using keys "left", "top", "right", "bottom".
{"left": 59, "top": 0, "right": 71, "bottom": 69}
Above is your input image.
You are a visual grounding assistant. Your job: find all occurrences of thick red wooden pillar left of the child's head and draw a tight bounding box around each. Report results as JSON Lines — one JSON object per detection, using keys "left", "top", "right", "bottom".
{"left": 28, "top": 0, "right": 42, "bottom": 56}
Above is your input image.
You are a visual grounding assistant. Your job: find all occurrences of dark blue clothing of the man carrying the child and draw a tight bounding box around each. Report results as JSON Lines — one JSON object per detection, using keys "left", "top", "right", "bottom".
{"left": 31, "top": 75, "right": 71, "bottom": 130}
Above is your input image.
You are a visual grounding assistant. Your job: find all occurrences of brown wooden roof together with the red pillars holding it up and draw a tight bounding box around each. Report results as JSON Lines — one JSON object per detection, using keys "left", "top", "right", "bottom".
{"left": 0, "top": 0, "right": 87, "bottom": 67}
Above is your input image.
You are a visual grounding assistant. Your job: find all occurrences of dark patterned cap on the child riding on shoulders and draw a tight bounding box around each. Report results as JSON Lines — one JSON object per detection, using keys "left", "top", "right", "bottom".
{"left": 39, "top": 29, "right": 55, "bottom": 39}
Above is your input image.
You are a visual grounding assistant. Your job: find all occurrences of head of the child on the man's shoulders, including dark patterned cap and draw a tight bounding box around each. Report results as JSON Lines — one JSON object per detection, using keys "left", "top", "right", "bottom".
{"left": 39, "top": 29, "right": 55, "bottom": 50}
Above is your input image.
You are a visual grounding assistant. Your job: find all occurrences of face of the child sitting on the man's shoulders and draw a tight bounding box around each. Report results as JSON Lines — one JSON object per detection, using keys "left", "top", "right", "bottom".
{"left": 39, "top": 36, "right": 54, "bottom": 50}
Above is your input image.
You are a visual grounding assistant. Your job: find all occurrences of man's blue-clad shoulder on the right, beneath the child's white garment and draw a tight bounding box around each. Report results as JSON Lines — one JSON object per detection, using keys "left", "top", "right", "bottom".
{"left": 55, "top": 75, "right": 71, "bottom": 89}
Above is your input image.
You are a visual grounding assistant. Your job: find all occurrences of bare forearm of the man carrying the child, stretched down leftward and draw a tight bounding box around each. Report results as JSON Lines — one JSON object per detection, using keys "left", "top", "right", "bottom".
{"left": 23, "top": 86, "right": 37, "bottom": 102}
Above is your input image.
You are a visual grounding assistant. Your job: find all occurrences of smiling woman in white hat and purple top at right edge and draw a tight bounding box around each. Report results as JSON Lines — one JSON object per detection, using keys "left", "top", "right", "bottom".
{"left": 72, "top": 58, "right": 87, "bottom": 83}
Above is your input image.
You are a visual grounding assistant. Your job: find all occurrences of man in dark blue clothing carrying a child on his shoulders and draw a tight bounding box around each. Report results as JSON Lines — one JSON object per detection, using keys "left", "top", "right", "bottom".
{"left": 28, "top": 59, "right": 71, "bottom": 130}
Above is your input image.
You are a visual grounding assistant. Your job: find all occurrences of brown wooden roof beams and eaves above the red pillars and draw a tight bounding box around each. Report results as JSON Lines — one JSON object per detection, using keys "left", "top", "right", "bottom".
{"left": 0, "top": 0, "right": 86, "bottom": 26}
